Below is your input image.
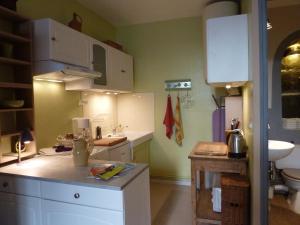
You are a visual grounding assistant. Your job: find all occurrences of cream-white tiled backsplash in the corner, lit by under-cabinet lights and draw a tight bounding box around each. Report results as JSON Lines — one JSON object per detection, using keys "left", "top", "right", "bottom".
{"left": 81, "top": 92, "right": 154, "bottom": 137}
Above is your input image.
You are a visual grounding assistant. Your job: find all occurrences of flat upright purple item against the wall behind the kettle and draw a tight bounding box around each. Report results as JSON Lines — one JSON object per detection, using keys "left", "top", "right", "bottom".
{"left": 212, "top": 107, "right": 226, "bottom": 143}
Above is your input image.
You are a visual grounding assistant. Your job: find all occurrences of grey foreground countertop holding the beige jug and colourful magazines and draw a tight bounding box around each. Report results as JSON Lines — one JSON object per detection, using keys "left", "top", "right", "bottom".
{"left": 0, "top": 156, "right": 148, "bottom": 190}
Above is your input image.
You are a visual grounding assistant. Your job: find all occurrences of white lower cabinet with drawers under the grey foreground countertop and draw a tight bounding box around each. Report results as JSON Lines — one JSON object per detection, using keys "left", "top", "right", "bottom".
{"left": 0, "top": 169, "right": 151, "bottom": 225}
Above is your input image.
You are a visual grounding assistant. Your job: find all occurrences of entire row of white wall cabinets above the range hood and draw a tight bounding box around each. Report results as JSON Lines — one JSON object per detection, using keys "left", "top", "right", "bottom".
{"left": 34, "top": 19, "right": 133, "bottom": 92}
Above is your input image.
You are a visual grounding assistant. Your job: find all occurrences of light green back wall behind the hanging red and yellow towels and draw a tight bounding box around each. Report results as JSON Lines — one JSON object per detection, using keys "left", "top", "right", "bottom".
{"left": 117, "top": 18, "right": 215, "bottom": 178}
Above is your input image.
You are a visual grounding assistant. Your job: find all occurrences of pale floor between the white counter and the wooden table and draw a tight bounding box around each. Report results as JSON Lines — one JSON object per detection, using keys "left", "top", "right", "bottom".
{"left": 150, "top": 181, "right": 192, "bottom": 225}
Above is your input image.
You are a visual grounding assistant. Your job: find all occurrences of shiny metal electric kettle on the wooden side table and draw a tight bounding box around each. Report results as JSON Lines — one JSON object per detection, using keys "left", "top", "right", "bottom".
{"left": 227, "top": 129, "right": 247, "bottom": 158}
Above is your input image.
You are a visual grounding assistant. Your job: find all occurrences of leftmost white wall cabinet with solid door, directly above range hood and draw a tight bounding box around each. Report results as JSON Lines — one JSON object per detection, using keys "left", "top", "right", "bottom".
{"left": 34, "top": 19, "right": 90, "bottom": 68}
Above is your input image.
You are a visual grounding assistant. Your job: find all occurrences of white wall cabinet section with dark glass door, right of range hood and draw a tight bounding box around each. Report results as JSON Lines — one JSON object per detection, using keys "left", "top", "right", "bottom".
{"left": 65, "top": 38, "right": 133, "bottom": 92}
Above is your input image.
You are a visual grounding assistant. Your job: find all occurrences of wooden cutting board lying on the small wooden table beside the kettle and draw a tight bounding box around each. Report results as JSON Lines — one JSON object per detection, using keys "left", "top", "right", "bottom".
{"left": 193, "top": 142, "right": 228, "bottom": 156}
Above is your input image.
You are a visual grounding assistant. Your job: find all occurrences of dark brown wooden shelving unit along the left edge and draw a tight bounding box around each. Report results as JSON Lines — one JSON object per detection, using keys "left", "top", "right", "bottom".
{"left": 0, "top": 6, "right": 35, "bottom": 166}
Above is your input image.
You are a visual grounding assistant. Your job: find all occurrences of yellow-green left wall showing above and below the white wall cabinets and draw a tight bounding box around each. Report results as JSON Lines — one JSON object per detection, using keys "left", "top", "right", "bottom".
{"left": 17, "top": 0, "right": 116, "bottom": 149}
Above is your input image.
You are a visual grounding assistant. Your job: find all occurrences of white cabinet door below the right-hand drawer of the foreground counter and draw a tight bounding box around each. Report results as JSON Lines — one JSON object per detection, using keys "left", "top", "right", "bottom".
{"left": 42, "top": 200, "right": 124, "bottom": 225}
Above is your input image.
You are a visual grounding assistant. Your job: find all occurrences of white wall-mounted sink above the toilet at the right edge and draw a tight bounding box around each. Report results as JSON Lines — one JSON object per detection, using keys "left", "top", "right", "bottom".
{"left": 268, "top": 140, "right": 295, "bottom": 161}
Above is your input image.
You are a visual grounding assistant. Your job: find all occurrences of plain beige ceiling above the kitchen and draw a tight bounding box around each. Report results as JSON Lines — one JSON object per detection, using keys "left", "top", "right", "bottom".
{"left": 77, "top": 0, "right": 209, "bottom": 26}
